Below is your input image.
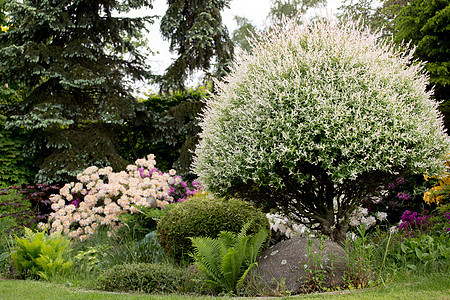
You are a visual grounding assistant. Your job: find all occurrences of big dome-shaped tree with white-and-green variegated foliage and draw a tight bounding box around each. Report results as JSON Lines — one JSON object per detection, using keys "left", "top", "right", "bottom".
{"left": 193, "top": 19, "right": 450, "bottom": 241}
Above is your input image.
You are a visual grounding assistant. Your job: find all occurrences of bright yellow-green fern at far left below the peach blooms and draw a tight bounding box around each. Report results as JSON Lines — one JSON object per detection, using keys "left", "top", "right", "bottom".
{"left": 11, "top": 228, "right": 73, "bottom": 280}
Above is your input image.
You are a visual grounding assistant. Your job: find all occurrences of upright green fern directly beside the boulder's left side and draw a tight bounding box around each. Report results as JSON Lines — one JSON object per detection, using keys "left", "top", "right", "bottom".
{"left": 190, "top": 222, "right": 268, "bottom": 294}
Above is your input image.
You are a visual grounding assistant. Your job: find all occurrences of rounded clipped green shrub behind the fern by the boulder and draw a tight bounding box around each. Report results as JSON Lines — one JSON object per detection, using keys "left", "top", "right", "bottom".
{"left": 156, "top": 193, "right": 270, "bottom": 260}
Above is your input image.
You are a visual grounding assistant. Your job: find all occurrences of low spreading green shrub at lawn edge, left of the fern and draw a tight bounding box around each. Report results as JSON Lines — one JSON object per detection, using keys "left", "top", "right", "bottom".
{"left": 98, "top": 263, "right": 210, "bottom": 294}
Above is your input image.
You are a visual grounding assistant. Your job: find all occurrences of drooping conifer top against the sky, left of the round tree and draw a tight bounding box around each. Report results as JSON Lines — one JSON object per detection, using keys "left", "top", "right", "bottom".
{"left": 157, "top": 0, "right": 233, "bottom": 92}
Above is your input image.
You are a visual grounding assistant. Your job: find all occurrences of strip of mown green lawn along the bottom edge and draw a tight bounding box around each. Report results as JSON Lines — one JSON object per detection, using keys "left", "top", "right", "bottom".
{"left": 0, "top": 273, "right": 450, "bottom": 300}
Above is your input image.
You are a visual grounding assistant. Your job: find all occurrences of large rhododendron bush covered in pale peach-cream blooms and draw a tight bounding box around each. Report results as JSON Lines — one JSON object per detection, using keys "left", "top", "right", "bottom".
{"left": 39, "top": 154, "right": 199, "bottom": 240}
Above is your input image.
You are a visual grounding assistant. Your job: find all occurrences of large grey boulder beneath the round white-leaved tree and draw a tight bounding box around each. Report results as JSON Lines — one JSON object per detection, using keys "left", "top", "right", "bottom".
{"left": 249, "top": 237, "right": 347, "bottom": 294}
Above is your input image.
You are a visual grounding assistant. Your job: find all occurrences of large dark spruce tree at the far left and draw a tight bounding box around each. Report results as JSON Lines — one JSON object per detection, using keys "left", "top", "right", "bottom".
{"left": 0, "top": 0, "right": 151, "bottom": 182}
